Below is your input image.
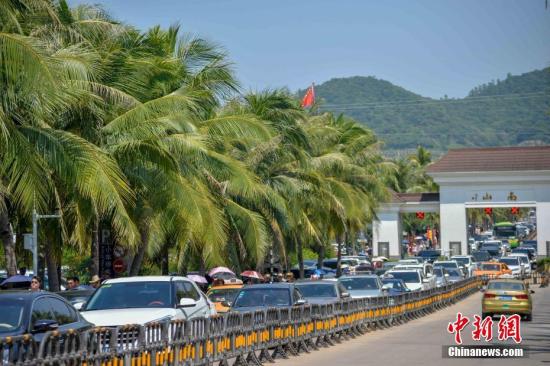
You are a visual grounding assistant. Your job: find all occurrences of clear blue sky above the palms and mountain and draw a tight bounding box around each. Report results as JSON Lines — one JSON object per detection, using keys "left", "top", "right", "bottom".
{"left": 69, "top": 0, "right": 550, "bottom": 98}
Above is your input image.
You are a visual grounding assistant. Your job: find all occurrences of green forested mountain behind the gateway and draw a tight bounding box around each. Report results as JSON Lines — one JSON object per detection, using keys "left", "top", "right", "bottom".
{"left": 306, "top": 68, "right": 550, "bottom": 154}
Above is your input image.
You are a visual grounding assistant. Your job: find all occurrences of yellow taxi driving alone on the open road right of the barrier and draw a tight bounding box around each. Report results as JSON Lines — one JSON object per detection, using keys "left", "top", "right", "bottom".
{"left": 481, "top": 279, "right": 535, "bottom": 321}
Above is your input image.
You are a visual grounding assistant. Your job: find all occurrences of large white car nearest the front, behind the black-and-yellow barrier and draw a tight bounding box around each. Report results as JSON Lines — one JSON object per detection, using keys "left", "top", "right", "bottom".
{"left": 81, "top": 276, "right": 216, "bottom": 326}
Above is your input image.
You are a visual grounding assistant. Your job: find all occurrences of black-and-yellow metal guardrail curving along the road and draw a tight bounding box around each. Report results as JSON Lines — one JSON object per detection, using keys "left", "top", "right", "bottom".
{"left": 0, "top": 278, "right": 481, "bottom": 366}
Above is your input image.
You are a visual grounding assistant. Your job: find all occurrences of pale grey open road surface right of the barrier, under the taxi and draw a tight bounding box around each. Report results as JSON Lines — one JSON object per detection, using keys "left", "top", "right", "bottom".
{"left": 277, "top": 285, "right": 550, "bottom": 366}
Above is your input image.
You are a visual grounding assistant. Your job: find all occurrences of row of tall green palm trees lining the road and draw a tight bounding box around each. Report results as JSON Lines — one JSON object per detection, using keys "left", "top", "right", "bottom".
{"left": 0, "top": 0, "right": 434, "bottom": 288}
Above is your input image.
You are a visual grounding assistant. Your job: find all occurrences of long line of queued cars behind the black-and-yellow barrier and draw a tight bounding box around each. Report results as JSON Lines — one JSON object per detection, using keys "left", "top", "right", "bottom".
{"left": 0, "top": 243, "right": 532, "bottom": 344}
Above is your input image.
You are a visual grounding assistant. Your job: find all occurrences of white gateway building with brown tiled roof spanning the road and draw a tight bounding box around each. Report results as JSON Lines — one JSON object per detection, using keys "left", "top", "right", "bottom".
{"left": 373, "top": 146, "right": 550, "bottom": 257}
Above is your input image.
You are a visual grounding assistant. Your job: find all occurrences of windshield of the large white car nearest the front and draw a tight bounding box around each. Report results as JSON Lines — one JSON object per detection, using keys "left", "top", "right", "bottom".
{"left": 86, "top": 281, "right": 173, "bottom": 311}
